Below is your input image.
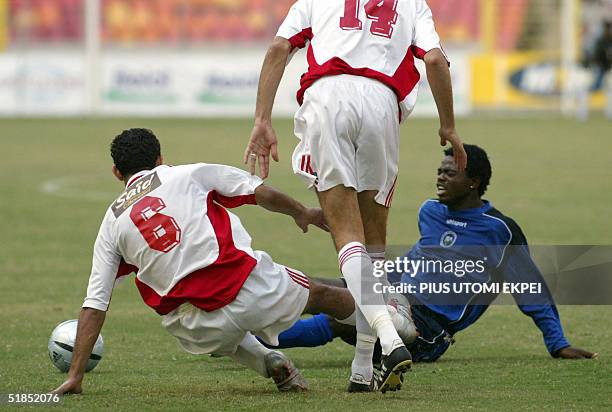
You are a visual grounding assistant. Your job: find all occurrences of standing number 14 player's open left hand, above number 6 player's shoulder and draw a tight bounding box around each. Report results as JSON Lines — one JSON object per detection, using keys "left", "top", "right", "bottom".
{"left": 243, "top": 122, "right": 278, "bottom": 179}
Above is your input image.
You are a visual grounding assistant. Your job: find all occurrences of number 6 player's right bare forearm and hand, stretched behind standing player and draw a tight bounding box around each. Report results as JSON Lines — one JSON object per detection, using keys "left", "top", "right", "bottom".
{"left": 255, "top": 185, "right": 329, "bottom": 233}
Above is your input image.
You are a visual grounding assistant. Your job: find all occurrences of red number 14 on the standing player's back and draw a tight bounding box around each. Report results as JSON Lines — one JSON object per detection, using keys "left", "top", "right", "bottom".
{"left": 340, "top": 0, "right": 397, "bottom": 39}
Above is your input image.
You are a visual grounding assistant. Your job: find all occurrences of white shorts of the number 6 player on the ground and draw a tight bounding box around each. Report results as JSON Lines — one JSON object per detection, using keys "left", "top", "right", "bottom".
{"left": 162, "top": 251, "right": 310, "bottom": 355}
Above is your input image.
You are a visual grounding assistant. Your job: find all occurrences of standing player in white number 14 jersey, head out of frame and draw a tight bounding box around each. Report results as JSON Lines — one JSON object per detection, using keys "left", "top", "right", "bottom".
{"left": 244, "top": 0, "right": 467, "bottom": 392}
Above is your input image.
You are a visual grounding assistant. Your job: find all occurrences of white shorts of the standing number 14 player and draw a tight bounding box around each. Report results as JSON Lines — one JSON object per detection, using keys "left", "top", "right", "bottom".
{"left": 292, "top": 75, "right": 400, "bottom": 207}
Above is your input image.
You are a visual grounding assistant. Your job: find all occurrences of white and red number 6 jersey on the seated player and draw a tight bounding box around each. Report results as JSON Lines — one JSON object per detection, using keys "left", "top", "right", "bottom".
{"left": 83, "top": 163, "right": 262, "bottom": 314}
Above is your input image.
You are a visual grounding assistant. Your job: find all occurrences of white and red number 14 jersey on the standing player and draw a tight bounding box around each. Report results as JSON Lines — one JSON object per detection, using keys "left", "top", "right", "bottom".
{"left": 277, "top": 0, "right": 442, "bottom": 120}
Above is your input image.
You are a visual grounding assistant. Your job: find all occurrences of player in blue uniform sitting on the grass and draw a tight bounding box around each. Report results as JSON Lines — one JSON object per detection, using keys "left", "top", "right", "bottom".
{"left": 272, "top": 145, "right": 597, "bottom": 362}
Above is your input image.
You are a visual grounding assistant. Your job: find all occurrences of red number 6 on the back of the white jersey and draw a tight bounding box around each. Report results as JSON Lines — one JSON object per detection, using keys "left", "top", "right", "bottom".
{"left": 130, "top": 196, "right": 181, "bottom": 253}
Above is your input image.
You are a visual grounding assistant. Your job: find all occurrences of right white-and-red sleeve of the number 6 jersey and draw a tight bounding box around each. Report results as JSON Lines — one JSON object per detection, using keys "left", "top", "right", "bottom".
{"left": 192, "top": 163, "right": 263, "bottom": 208}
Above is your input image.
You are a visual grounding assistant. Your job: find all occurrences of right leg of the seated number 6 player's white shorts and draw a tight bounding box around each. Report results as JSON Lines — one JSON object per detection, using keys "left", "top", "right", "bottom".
{"left": 227, "top": 251, "right": 310, "bottom": 345}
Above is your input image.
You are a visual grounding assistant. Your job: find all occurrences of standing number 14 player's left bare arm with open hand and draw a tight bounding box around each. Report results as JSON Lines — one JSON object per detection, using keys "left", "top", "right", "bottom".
{"left": 244, "top": 37, "right": 291, "bottom": 179}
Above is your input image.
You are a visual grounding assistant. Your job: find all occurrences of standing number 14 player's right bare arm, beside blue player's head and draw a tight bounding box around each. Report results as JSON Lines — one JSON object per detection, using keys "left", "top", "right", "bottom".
{"left": 424, "top": 49, "right": 467, "bottom": 171}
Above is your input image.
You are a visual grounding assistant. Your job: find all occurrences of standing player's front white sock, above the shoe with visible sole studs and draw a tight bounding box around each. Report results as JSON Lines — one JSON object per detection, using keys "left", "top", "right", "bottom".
{"left": 338, "top": 242, "right": 403, "bottom": 355}
